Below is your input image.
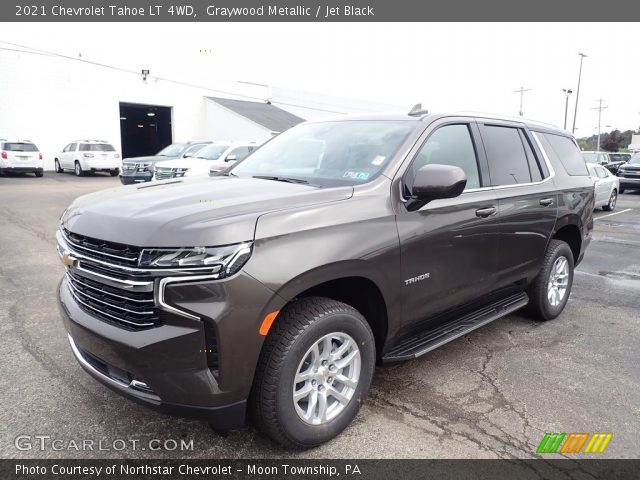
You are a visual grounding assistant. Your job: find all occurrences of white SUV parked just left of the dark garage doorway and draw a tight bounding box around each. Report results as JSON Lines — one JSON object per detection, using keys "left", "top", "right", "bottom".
{"left": 55, "top": 140, "right": 120, "bottom": 177}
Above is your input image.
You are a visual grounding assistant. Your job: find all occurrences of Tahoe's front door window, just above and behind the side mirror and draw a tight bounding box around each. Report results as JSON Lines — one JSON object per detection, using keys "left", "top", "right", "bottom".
{"left": 405, "top": 124, "right": 480, "bottom": 190}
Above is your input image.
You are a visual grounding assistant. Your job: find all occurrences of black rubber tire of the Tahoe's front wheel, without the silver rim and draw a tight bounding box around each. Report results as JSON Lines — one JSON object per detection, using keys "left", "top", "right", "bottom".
{"left": 249, "top": 297, "right": 376, "bottom": 449}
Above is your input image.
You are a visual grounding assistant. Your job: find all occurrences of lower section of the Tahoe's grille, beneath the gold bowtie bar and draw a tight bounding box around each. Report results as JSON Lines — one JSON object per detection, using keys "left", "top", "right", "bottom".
{"left": 67, "top": 269, "right": 160, "bottom": 329}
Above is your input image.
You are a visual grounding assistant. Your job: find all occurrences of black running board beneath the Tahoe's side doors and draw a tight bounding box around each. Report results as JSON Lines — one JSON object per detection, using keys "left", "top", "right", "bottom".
{"left": 382, "top": 292, "right": 529, "bottom": 363}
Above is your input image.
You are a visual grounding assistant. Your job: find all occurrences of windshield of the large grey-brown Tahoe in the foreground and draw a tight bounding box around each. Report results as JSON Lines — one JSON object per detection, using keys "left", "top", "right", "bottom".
{"left": 231, "top": 120, "right": 416, "bottom": 186}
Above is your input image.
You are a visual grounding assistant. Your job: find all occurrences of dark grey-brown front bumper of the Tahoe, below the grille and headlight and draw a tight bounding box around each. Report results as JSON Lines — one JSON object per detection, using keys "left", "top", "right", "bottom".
{"left": 59, "top": 272, "right": 279, "bottom": 430}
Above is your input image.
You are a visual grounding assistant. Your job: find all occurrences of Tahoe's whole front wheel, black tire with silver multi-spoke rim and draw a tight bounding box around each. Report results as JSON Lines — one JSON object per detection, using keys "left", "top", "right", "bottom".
{"left": 250, "top": 297, "right": 376, "bottom": 448}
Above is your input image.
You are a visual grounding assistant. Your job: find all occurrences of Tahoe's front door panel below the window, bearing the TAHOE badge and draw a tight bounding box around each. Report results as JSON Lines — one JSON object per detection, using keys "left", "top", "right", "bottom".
{"left": 397, "top": 190, "right": 500, "bottom": 325}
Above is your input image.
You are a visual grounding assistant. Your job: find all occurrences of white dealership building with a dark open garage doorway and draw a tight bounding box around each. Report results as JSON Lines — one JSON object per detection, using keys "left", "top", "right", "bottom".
{"left": 0, "top": 48, "right": 398, "bottom": 170}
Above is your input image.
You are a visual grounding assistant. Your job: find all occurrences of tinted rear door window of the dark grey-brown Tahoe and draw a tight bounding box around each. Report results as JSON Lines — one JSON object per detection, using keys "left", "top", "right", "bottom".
{"left": 482, "top": 125, "right": 531, "bottom": 186}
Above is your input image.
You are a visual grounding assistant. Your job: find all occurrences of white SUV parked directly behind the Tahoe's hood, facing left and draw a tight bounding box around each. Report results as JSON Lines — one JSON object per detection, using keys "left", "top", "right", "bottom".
{"left": 155, "top": 142, "right": 258, "bottom": 180}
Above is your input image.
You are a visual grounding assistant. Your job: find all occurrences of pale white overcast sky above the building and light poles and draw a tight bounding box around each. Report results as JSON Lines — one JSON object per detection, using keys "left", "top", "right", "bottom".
{"left": 0, "top": 23, "right": 640, "bottom": 137}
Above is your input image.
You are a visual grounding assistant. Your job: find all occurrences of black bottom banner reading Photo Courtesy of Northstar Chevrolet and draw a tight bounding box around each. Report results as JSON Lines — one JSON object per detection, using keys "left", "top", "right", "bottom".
{"left": 0, "top": 458, "right": 640, "bottom": 480}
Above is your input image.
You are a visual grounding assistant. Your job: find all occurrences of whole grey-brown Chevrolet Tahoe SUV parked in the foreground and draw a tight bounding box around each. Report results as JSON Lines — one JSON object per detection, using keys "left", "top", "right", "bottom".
{"left": 57, "top": 113, "right": 594, "bottom": 447}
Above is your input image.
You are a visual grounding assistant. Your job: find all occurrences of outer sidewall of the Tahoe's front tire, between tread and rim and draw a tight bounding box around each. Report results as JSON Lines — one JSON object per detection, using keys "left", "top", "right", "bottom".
{"left": 276, "top": 311, "right": 376, "bottom": 446}
